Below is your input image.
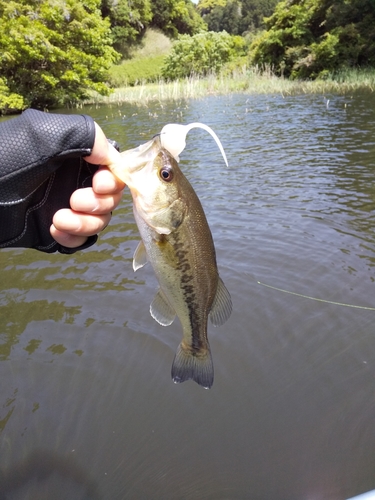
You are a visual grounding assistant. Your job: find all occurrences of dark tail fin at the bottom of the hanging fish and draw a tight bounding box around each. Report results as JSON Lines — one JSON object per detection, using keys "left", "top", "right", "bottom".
{"left": 172, "top": 343, "right": 214, "bottom": 389}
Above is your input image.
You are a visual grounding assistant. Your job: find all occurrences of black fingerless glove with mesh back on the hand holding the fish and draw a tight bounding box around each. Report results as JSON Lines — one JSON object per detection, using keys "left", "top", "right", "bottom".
{"left": 0, "top": 109, "right": 98, "bottom": 253}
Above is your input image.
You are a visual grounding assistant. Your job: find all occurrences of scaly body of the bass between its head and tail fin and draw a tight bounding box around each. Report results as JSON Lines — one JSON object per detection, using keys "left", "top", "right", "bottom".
{"left": 135, "top": 157, "right": 218, "bottom": 336}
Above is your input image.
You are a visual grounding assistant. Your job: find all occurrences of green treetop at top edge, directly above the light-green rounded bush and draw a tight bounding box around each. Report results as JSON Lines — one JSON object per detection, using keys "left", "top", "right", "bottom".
{"left": 151, "top": 0, "right": 206, "bottom": 38}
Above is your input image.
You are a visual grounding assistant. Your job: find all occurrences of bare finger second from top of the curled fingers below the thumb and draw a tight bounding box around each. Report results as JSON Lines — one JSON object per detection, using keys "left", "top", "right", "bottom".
{"left": 70, "top": 188, "right": 122, "bottom": 215}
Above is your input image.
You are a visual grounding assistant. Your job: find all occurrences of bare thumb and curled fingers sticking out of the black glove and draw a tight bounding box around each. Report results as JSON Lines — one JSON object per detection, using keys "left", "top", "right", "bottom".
{"left": 50, "top": 123, "right": 125, "bottom": 248}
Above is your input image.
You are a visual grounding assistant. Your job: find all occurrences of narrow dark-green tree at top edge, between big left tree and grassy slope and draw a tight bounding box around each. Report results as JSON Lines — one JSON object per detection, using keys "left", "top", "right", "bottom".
{"left": 101, "top": 0, "right": 152, "bottom": 54}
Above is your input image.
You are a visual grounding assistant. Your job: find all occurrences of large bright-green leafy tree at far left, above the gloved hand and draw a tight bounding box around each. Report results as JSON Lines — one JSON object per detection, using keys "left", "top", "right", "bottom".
{"left": 0, "top": 0, "right": 118, "bottom": 111}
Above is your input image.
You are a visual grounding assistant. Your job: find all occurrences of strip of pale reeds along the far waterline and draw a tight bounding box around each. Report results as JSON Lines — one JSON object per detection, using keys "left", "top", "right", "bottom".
{"left": 86, "top": 66, "right": 375, "bottom": 105}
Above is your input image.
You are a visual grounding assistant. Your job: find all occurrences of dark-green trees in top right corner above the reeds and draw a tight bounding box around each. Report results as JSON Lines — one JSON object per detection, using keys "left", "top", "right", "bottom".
{"left": 250, "top": 0, "right": 375, "bottom": 78}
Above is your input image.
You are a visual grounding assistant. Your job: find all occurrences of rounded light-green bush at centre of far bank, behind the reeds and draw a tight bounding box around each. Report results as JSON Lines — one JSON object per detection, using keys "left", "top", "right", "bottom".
{"left": 162, "top": 31, "right": 245, "bottom": 80}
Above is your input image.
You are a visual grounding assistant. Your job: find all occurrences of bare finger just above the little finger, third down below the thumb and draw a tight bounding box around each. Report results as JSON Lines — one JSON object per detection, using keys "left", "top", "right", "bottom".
{"left": 52, "top": 208, "right": 111, "bottom": 236}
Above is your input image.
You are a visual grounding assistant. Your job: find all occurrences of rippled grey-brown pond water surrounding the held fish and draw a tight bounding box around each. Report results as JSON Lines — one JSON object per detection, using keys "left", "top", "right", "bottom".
{"left": 0, "top": 93, "right": 375, "bottom": 500}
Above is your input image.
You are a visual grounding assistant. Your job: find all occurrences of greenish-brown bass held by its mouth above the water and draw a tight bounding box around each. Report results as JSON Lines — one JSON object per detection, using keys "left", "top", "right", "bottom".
{"left": 109, "top": 124, "right": 232, "bottom": 389}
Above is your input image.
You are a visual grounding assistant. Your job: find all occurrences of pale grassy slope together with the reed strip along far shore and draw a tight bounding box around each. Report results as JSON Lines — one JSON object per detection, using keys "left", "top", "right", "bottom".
{"left": 97, "top": 29, "right": 375, "bottom": 105}
